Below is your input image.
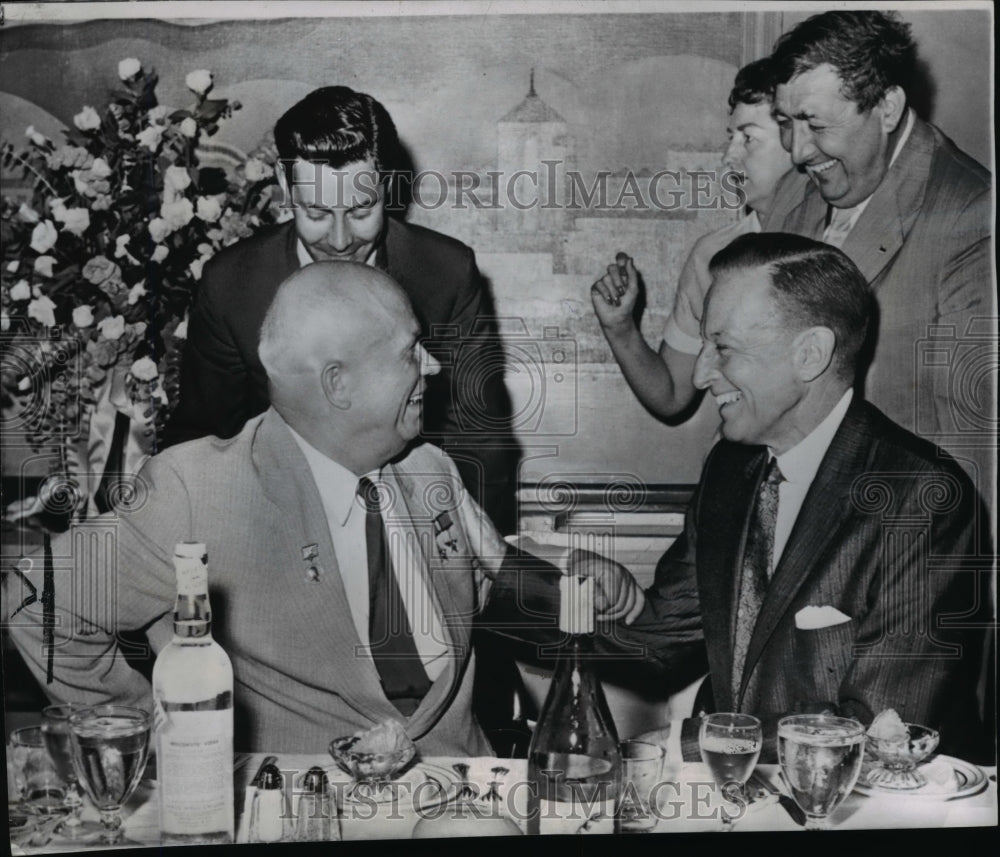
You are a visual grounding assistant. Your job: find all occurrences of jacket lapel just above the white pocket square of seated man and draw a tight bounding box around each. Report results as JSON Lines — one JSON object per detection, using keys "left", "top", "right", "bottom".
{"left": 740, "top": 400, "right": 872, "bottom": 698}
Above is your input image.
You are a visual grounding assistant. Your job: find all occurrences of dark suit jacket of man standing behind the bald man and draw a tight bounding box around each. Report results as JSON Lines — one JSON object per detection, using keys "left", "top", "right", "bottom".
{"left": 165, "top": 218, "right": 517, "bottom": 532}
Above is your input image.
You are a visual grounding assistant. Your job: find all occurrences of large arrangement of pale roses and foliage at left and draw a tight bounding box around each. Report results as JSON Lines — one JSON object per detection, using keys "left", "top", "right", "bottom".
{"left": 0, "top": 58, "right": 280, "bottom": 516}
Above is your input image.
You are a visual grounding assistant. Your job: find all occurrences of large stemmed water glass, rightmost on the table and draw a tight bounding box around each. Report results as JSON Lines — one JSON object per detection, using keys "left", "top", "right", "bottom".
{"left": 778, "top": 714, "right": 865, "bottom": 830}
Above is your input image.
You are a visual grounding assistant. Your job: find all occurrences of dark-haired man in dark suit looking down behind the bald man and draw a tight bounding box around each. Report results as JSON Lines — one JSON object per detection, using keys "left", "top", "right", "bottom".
{"left": 167, "top": 86, "right": 517, "bottom": 532}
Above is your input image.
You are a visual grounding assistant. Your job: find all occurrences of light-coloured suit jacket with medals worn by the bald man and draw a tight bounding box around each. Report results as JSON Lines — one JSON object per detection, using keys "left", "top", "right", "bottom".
{"left": 3, "top": 410, "right": 524, "bottom": 755}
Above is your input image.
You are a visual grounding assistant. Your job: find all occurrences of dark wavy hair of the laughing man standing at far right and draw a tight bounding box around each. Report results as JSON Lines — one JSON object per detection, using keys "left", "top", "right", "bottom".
{"left": 771, "top": 11, "right": 917, "bottom": 112}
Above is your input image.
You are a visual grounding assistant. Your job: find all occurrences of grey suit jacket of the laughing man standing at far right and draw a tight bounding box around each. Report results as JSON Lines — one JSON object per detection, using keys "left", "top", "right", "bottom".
{"left": 763, "top": 118, "right": 997, "bottom": 497}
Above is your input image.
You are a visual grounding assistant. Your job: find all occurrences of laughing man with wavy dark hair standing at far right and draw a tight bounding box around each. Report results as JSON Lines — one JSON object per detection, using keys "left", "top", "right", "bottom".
{"left": 762, "top": 10, "right": 997, "bottom": 498}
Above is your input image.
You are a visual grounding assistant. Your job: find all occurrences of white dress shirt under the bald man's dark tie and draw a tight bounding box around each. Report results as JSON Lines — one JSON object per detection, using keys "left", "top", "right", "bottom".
{"left": 286, "top": 423, "right": 448, "bottom": 681}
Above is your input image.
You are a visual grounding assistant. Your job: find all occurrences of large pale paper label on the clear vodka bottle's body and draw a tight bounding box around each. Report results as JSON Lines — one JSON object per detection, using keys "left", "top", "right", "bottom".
{"left": 156, "top": 708, "right": 233, "bottom": 840}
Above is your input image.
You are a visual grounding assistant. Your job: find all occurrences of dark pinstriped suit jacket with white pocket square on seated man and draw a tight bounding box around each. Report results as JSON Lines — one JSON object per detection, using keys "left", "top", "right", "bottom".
{"left": 618, "top": 401, "right": 991, "bottom": 758}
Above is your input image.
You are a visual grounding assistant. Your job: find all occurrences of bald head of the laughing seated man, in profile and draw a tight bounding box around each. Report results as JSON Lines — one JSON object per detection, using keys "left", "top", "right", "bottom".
{"left": 258, "top": 262, "right": 438, "bottom": 475}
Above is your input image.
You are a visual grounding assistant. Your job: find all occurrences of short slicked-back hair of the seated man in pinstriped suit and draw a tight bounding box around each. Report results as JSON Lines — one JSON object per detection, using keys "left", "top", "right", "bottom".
{"left": 708, "top": 232, "right": 874, "bottom": 381}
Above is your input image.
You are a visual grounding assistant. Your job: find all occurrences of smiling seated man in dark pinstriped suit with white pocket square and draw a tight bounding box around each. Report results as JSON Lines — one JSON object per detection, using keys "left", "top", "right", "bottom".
{"left": 500, "top": 233, "right": 993, "bottom": 761}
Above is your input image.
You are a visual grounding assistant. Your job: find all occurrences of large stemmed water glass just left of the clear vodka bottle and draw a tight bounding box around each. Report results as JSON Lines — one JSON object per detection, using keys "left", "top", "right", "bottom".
{"left": 69, "top": 705, "right": 152, "bottom": 845}
